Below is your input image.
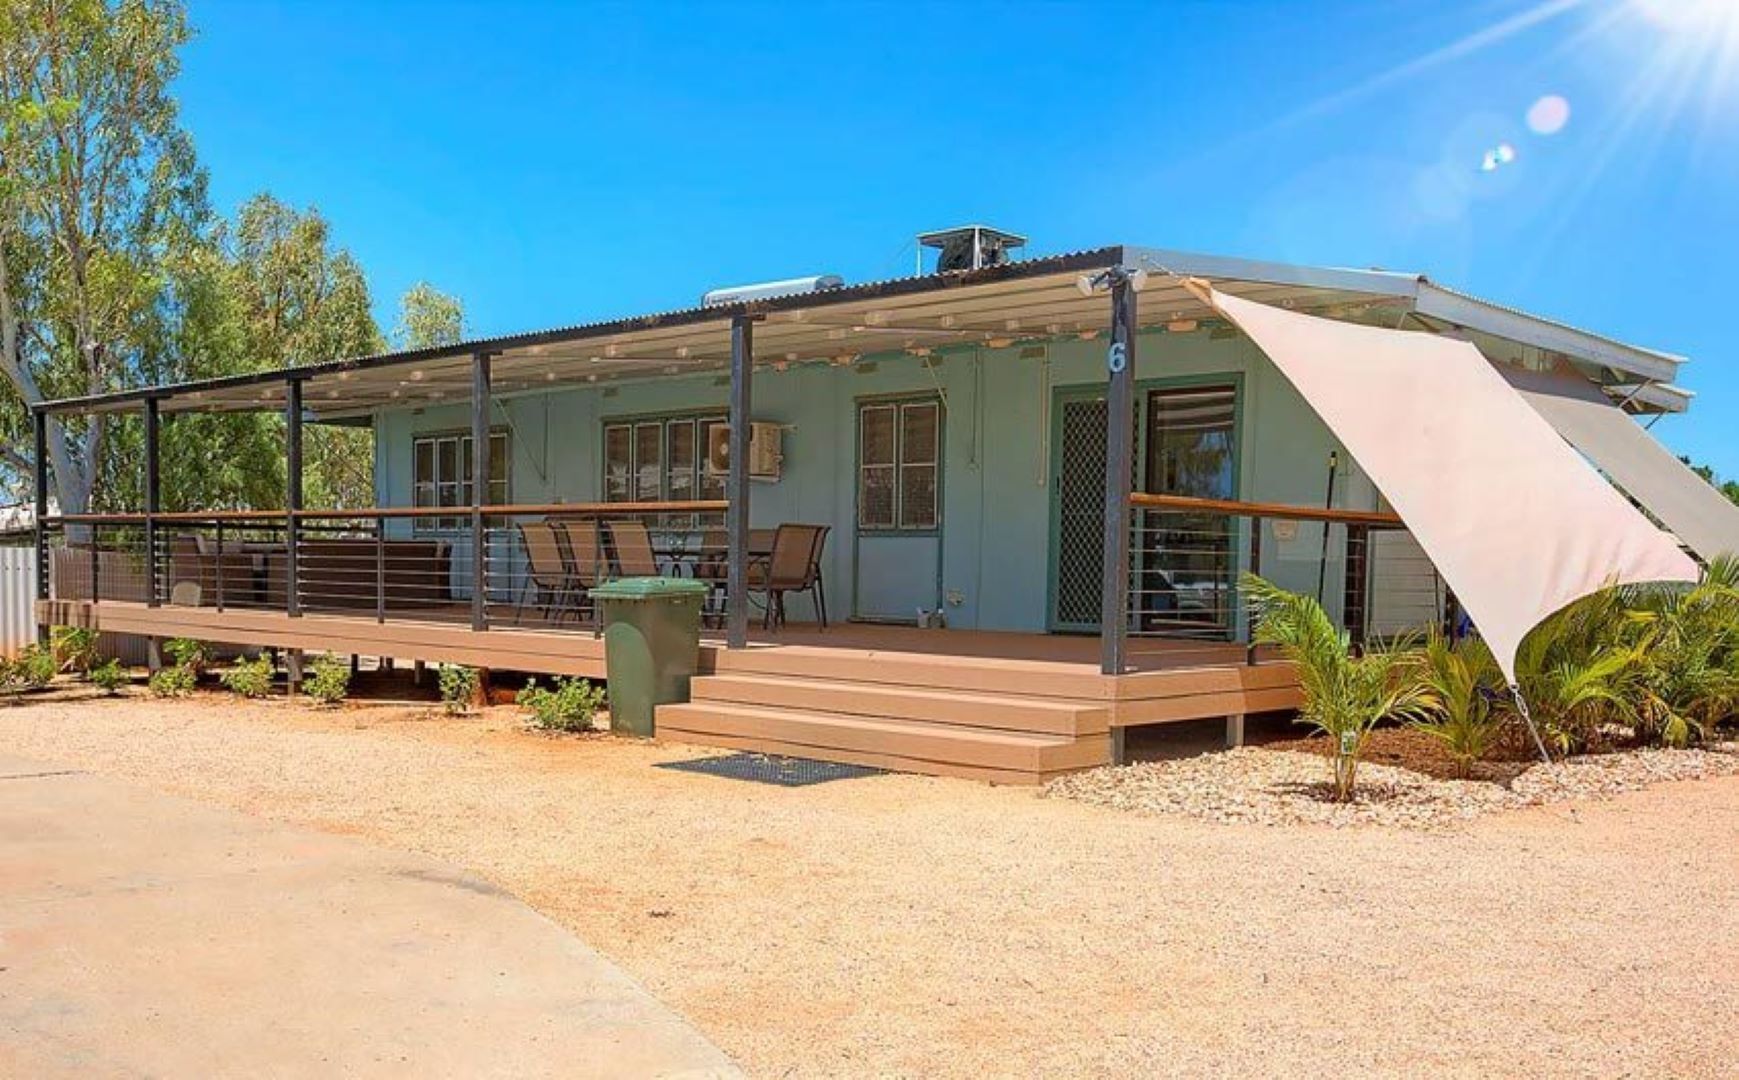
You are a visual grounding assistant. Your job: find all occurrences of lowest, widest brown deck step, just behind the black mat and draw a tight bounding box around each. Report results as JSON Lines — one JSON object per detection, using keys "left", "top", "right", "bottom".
{"left": 657, "top": 701, "right": 1111, "bottom": 784}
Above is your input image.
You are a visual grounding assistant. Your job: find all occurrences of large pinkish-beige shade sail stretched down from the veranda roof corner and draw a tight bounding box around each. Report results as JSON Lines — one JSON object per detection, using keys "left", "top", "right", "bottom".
{"left": 1210, "top": 283, "right": 1697, "bottom": 682}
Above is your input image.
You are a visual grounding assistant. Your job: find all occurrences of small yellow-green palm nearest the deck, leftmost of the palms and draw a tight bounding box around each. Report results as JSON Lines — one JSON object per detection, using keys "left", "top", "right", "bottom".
{"left": 1240, "top": 574, "right": 1433, "bottom": 802}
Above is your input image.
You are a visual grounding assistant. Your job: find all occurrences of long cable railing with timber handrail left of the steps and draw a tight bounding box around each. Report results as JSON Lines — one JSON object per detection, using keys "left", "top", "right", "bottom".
{"left": 35, "top": 501, "right": 726, "bottom": 630}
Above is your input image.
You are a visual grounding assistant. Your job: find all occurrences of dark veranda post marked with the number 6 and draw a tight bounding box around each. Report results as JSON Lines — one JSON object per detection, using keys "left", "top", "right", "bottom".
{"left": 1099, "top": 266, "right": 1136, "bottom": 675}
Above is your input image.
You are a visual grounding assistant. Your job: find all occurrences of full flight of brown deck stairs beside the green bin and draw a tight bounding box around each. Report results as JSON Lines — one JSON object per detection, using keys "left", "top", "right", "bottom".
{"left": 657, "top": 671, "right": 1111, "bottom": 784}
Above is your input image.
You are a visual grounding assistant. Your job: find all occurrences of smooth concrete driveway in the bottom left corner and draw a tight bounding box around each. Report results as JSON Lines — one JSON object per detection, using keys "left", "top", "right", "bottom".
{"left": 0, "top": 757, "right": 737, "bottom": 1077}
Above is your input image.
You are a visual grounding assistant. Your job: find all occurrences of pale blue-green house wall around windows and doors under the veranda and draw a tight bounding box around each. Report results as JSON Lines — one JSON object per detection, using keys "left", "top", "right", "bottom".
{"left": 376, "top": 330, "right": 1376, "bottom": 631}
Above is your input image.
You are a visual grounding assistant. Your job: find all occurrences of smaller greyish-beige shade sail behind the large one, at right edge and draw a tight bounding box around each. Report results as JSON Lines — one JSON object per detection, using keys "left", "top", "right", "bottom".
{"left": 1502, "top": 369, "right": 1739, "bottom": 560}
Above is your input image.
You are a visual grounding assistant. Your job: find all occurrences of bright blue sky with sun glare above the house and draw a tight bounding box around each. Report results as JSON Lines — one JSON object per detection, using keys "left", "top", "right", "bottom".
{"left": 179, "top": 0, "right": 1739, "bottom": 477}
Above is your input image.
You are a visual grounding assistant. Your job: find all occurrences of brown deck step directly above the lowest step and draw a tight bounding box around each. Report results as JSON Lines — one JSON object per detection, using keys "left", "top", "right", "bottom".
{"left": 690, "top": 675, "right": 1109, "bottom": 736}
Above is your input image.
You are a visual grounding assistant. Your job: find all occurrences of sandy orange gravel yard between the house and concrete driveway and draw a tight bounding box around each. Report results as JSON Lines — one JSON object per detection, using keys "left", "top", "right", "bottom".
{"left": 0, "top": 685, "right": 1739, "bottom": 1078}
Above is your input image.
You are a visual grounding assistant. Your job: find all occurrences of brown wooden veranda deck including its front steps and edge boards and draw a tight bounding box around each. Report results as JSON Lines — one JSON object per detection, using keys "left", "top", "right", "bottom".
{"left": 38, "top": 600, "right": 1299, "bottom": 783}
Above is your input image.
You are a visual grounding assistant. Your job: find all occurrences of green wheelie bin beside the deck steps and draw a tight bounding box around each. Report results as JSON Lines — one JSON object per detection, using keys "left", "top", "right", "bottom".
{"left": 591, "top": 577, "right": 708, "bottom": 737}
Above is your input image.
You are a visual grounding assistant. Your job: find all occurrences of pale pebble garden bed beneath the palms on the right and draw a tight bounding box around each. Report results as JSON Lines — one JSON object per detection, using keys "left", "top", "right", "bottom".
{"left": 1045, "top": 744, "right": 1739, "bottom": 828}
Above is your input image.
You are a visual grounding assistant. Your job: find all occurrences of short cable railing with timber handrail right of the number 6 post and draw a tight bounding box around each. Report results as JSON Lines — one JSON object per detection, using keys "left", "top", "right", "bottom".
{"left": 1125, "top": 492, "right": 1450, "bottom": 663}
